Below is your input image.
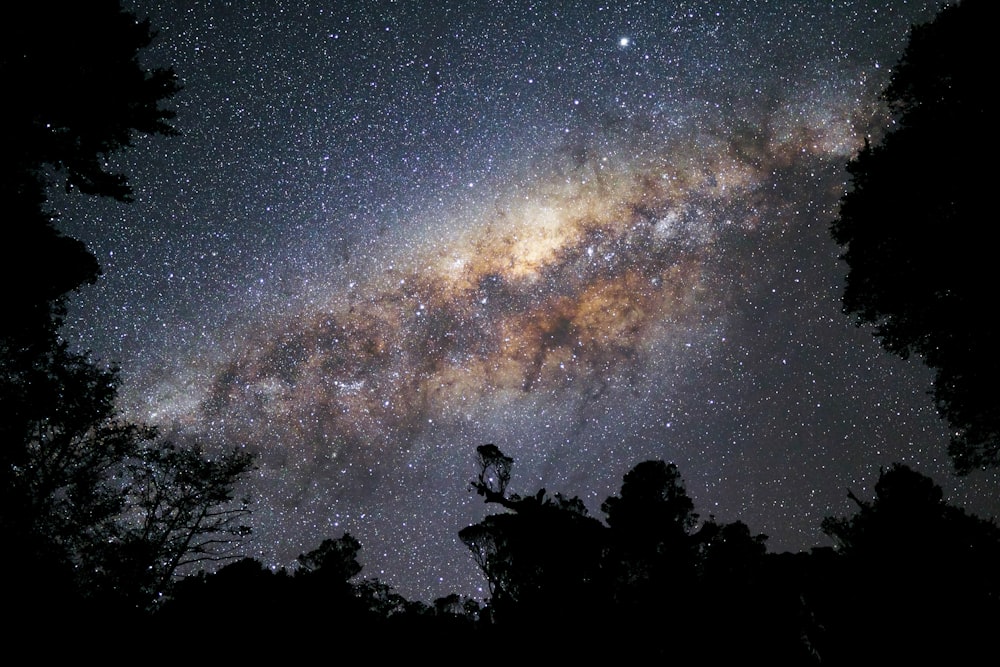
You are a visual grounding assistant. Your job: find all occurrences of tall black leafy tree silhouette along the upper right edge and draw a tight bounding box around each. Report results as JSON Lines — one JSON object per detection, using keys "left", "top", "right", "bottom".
{"left": 831, "top": 0, "right": 1000, "bottom": 473}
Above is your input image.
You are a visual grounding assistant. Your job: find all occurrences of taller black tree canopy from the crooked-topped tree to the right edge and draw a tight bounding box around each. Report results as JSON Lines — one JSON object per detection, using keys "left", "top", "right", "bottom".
{"left": 459, "top": 445, "right": 1000, "bottom": 665}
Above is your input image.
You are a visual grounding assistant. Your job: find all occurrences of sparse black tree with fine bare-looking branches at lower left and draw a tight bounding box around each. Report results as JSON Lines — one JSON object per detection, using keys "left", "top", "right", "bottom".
{"left": 0, "top": 370, "right": 254, "bottom": 612}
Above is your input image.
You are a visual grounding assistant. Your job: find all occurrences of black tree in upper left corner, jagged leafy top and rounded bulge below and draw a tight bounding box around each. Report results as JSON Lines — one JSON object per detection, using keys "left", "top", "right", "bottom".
{"left": 0, "top": 0, "right": 179, "bottom": 346}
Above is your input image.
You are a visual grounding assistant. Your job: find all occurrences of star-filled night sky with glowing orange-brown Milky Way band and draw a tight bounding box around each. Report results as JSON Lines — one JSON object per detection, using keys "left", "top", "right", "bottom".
{"left": 60, "top": 0, "right": 997, "bottom": 602}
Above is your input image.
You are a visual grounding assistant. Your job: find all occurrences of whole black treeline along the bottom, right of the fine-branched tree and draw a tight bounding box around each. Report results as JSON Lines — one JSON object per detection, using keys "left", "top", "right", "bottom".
{"left": 149, "top": 445, "right": 1000, "bottom": 665}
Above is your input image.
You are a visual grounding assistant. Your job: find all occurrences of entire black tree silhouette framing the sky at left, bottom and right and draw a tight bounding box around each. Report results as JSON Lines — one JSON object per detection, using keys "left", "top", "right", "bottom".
{"left": 0, "top": 0, "right": 1000, "bottom": 665}
